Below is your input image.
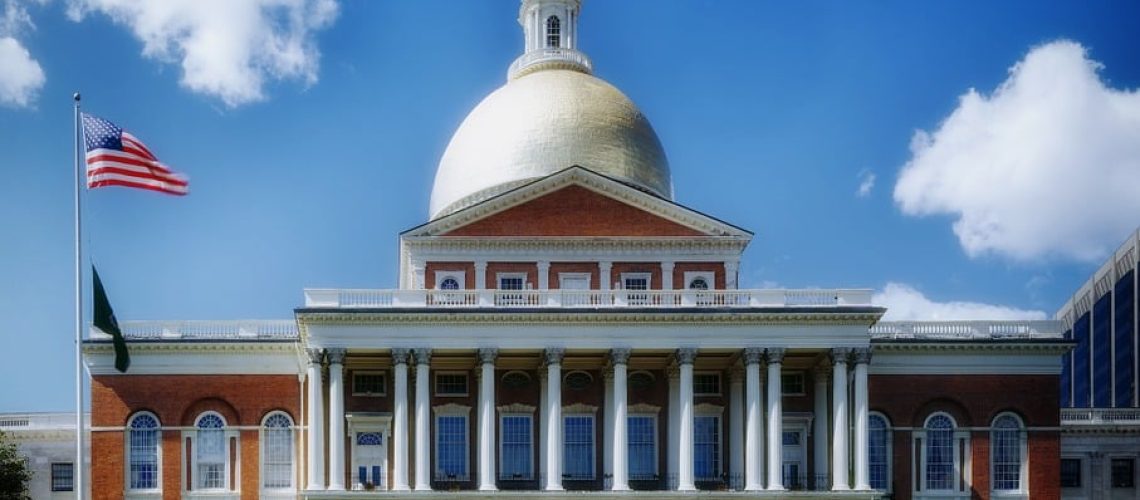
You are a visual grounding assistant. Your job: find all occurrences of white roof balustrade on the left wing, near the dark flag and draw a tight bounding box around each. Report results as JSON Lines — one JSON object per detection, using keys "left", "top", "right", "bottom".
{"left": 104, "top": 320, "right": 298, "bottom": 339}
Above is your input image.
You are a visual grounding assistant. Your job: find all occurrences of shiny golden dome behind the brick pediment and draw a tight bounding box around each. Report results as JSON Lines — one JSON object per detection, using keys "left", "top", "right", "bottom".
{"left": 431, "top": 68, "right": 673, "bottom": 219}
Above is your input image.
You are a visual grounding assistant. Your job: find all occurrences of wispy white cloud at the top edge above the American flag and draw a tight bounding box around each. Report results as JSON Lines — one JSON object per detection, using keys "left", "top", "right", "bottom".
{"left": 68, "top": 0, "right": 337, "bottom": 107}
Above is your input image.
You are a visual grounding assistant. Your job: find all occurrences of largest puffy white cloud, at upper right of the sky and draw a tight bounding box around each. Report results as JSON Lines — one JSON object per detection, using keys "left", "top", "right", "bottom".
{"left": 894, "top": 40, "right": 1140, "bottom": 261}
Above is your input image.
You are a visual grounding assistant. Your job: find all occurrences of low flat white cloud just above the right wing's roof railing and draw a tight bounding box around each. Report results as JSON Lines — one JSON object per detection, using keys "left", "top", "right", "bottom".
{"left": 871, "top": 281, "right": 1045, "bottom": 321}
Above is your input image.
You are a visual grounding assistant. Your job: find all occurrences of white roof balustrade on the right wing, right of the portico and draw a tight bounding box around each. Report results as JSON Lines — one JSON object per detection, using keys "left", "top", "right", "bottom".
{"left": 871, "top": 320, "right": 1061, "bottom": 339}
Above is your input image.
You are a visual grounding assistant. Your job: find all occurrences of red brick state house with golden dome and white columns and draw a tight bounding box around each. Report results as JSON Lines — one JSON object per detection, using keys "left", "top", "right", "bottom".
{"left": 86, "top": 0, "right": 1071, "bottom": 499}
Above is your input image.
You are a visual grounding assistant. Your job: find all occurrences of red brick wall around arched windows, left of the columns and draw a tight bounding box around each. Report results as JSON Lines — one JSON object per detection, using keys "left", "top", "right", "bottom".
{"left": 91, "top": 375, "right": 300, "bottom": 500}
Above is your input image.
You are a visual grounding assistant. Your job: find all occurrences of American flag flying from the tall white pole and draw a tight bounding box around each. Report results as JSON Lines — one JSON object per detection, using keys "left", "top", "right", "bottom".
{"left": 82, "top": 113, "right": 189, "bottom": 196}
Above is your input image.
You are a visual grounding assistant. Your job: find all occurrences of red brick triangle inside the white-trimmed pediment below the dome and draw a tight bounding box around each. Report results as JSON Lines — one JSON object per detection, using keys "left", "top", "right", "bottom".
{"left": 445, "top": 186, "right": 702, "bottom": 236}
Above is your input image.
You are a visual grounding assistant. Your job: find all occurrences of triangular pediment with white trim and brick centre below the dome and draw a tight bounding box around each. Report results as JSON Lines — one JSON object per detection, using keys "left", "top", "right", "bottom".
{"left": 404, "top": 166, "right": 751, "bottom": 239}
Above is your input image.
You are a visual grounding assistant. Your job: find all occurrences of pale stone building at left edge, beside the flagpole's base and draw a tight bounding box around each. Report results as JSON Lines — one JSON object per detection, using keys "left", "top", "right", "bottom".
{"left": 0, "top": 413, "right": 91, "bottom": 500}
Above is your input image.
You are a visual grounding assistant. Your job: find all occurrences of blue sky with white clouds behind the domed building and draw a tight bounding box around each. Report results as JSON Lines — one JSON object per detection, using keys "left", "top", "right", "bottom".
{"left": 0, "top": 0, "right": 1140, "bottom": 411}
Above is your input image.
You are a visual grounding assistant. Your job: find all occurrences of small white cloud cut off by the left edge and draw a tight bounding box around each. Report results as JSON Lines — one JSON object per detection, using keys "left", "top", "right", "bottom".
{"left": 0, "top": 0, "right": 47, "bottom": 107}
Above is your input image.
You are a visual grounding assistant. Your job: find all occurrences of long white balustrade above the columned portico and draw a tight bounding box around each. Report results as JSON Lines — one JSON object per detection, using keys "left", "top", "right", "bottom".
{"left": 304, "top": 288, "right": 871, "bottom": 309}
